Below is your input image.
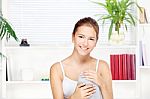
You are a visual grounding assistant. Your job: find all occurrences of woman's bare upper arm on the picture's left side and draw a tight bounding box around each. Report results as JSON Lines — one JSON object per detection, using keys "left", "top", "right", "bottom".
{"left": 50, "top": 63, "right": 64, "bottom": 99}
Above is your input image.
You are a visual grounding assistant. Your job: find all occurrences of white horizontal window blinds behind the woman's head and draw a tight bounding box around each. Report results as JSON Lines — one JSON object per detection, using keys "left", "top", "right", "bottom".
{"left": 7, "top": 0, "right": 136, "bottom": 45}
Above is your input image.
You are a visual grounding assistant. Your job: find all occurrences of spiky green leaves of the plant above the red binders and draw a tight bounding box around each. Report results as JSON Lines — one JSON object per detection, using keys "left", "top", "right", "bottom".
{"left": 92, "top": 0, "right": 140, "bottom": 43}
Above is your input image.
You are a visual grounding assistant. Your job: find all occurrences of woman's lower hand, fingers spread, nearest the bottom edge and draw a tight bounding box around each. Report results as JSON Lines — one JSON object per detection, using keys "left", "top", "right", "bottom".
{"left": 69, "top": 83, "right": 96, "bottom": 99}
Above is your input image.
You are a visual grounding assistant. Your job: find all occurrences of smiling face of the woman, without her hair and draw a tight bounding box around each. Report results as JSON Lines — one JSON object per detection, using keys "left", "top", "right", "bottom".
{"left": 73, "top": 25, "right": 97, "bottom": 55}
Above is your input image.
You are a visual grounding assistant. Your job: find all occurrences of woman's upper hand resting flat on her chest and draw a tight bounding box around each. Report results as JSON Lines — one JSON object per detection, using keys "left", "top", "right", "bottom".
{"left": 81, "top": 70, "right": 104, "bottom": 86}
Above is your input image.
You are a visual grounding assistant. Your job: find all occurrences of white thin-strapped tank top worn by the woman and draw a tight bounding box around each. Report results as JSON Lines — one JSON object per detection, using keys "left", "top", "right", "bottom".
{"left": 60, "top": 60, "right": 102, "bottom": 99}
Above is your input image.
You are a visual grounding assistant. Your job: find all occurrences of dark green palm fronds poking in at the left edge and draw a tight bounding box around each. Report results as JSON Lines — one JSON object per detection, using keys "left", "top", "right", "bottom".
{"left": 0, "top": 16, "right": 19, "bottom": 57}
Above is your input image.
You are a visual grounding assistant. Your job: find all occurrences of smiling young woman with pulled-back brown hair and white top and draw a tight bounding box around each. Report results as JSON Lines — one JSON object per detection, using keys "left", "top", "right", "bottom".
{"left": 50, "top": 17, "right": 113, "bottom": 99}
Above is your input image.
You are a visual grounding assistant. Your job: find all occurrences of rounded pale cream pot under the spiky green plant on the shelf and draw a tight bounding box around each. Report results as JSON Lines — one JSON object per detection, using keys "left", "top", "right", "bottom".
{"left": 109, "top": 31, "right": 125, "bottom": 45}
